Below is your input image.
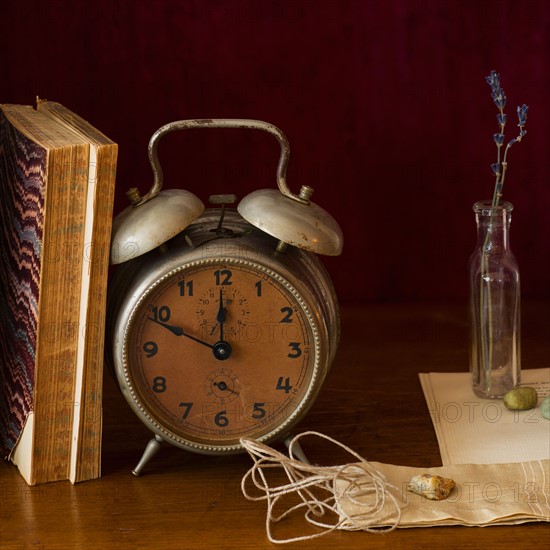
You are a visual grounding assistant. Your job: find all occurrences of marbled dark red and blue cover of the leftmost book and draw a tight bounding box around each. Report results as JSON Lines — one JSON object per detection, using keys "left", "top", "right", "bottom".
{"left": 0, "top": 112, "right": 48, "bottom": 464}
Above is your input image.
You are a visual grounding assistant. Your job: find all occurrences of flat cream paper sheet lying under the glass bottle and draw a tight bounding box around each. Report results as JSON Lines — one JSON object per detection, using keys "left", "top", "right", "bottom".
{"left": 419, "top": 368, "right": 550, "bottom": 466}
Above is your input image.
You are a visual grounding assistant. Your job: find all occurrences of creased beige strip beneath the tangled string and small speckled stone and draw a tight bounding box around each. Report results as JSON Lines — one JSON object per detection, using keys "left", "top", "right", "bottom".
{"left": 336, "top": 460, "right": 550, "bottom": 529}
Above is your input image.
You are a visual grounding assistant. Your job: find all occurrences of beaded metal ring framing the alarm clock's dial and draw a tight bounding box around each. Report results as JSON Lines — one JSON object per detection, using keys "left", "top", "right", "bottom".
{"left": 116, "top": 256, "right": 326, "bottom": 454}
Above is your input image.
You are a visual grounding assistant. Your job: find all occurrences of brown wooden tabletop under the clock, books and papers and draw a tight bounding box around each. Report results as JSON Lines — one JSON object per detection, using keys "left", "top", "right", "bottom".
{"left": 0, "top": 304, "right": 550, "bottom": 550}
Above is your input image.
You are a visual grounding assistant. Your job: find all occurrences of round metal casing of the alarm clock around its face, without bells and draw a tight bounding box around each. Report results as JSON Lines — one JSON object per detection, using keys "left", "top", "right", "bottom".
{"left": 107, "top": 208, "right": 340, "bottom": 454}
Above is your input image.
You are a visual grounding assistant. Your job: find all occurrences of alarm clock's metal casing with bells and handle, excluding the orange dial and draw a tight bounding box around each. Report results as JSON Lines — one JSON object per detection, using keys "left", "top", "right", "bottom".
{"left": 106, "top": 119, "right": 343, "bottom": 475}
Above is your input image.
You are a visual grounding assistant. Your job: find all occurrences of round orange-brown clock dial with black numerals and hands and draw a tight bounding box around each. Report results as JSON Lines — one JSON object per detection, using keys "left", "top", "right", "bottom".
{"left": 123, "top": 259, "right": 319, "bottom": 452}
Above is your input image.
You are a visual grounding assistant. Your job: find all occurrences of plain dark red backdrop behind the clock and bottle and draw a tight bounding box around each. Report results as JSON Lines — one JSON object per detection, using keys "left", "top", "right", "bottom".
{"left": 0, "top": 0, "right": 550, "bottom": 302}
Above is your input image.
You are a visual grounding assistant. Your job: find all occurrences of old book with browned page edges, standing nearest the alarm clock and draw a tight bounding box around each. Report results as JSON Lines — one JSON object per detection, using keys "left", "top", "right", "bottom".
{"left": 38, "top": 100, "right": 118, "bottom": 483}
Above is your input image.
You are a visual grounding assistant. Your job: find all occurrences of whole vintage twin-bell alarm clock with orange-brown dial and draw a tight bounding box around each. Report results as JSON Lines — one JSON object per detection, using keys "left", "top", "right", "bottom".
{"left": 108, "top": 119, "right": 343, "bottom": 475}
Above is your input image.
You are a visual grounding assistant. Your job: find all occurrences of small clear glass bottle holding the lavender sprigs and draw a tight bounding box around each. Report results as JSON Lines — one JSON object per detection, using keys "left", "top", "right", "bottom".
{"left": 469, "top": 201, "right": 521, "bottom": 399}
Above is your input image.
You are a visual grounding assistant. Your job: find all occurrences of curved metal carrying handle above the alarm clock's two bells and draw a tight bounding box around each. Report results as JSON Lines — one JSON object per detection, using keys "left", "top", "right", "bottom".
{"left": 134, "top": 119, "right": 309, "bottom": 206}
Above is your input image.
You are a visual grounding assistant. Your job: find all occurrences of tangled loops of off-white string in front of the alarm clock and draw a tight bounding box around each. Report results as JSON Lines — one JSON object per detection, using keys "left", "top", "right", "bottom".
{"left": 241, "top": 432, "right": 401, "bottom": 544}
